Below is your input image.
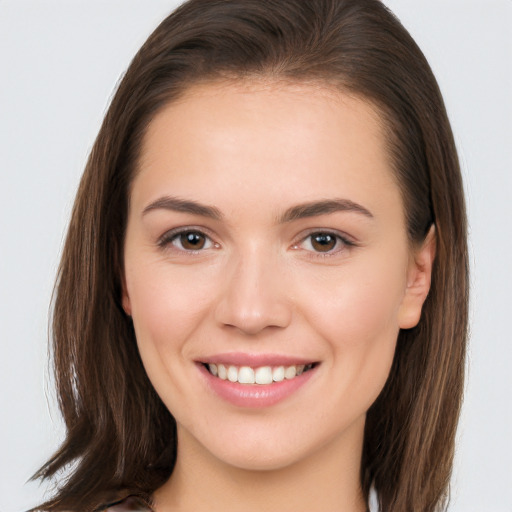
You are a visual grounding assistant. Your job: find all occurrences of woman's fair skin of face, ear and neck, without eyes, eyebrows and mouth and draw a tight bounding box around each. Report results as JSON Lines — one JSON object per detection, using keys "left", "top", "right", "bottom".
{"left": 123, "top": 82, "right": 435, "bottom": 512}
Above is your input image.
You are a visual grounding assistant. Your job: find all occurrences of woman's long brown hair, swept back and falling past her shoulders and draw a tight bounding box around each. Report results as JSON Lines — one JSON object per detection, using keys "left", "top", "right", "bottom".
{"left": 36, "top": 0, "right": 468, "bottom": 512}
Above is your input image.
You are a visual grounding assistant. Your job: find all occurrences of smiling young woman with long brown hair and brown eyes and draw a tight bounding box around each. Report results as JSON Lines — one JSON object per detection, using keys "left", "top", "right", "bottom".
{"left": 32, "top": 0, "right": 467, "bottom": 512}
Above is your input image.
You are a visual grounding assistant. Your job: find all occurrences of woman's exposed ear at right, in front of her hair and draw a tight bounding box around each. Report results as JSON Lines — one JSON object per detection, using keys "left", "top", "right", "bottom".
{"left": 398, "top": 224, "right": 436, "bottom": 329}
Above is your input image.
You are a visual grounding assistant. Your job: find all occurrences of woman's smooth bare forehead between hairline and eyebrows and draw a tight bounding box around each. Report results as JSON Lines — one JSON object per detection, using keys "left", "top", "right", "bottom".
{"left": 132, "top": 81, "right": 399, "bottom": 222}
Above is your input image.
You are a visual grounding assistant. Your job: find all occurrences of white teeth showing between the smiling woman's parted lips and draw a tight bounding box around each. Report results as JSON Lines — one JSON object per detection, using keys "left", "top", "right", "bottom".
{"left": 203, "top": 363, "right": 317, "bottom": 385}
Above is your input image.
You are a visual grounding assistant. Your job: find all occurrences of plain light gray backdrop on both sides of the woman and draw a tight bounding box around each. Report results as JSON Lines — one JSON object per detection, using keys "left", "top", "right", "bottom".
{"left": 0, "top": 0, "right": 512, "bottom": 512}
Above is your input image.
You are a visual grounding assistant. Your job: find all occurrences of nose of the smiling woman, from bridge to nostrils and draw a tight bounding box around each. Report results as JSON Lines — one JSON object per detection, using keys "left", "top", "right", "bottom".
{"left": 215, "top": 249, "right": 292, "bottom": 335}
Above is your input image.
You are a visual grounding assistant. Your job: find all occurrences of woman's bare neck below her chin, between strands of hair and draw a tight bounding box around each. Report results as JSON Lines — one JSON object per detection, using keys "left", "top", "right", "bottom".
{"left": 154, "top": 418, "right": 367, "bottom": 512}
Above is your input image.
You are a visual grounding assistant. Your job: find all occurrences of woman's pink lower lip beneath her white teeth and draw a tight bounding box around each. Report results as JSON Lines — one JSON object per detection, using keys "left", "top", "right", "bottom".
{"left": 197, "top": 363, "right": 317, "bottom": 408}
